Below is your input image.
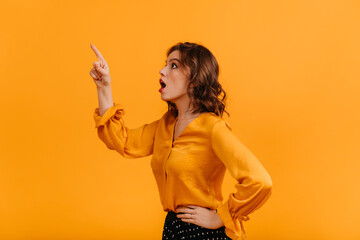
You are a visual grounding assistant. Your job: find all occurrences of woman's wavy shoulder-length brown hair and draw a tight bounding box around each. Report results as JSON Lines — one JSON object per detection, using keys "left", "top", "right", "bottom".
{"left": 167, "top": 42, "right": 230, "bottom": 117}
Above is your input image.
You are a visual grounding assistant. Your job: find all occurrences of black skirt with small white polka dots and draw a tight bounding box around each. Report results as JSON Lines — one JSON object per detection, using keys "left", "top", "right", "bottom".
{"left": 162, "top": 212, "right": 231, "bottom": 240}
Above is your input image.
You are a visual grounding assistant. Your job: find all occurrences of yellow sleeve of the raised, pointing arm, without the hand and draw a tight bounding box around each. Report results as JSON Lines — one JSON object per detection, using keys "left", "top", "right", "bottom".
{"left": 94, "top": 103, "right": 159, "bottom": 158}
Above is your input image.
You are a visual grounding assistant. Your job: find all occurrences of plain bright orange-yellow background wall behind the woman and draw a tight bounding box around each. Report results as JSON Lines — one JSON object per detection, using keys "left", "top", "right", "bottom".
{"left": 0, "top": 0, "right": 360, "bottom": 240}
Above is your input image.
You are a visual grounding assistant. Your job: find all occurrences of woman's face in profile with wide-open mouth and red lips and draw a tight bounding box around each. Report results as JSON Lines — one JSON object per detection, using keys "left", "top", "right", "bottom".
{"left": 159, "top": 50, "right": 190, "bottom": 102}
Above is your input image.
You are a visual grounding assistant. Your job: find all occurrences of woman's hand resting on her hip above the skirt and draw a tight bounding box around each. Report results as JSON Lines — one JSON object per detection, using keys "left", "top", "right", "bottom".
{"left": 176, "top": 205, "right": 224, "bottom": 229}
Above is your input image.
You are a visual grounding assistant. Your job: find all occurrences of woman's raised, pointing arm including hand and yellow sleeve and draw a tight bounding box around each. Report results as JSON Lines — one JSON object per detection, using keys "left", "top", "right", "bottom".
{"left": 90, "top": 44, "right": 159, "bottom": 158}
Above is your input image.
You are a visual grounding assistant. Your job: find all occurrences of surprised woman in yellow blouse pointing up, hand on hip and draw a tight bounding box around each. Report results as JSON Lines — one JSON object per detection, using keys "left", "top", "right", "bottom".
{"left": 90, "top": 42, "right": 272, "bottom": 239}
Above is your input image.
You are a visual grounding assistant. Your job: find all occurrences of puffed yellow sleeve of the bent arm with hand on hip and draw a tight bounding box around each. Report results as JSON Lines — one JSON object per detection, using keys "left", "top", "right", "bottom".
{"left": 211, "top": 119, "right": 272, "bottom": 239}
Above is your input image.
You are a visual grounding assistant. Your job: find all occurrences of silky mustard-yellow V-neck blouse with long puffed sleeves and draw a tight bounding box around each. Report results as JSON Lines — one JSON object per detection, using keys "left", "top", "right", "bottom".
{"left": 94, "top": 103, "right": 272, "bottom": 239}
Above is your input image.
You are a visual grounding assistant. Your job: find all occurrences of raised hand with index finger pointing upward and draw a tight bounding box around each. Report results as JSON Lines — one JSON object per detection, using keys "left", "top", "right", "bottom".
{"left": 90, "top": 44, "right": 111, "bottom": 88}
